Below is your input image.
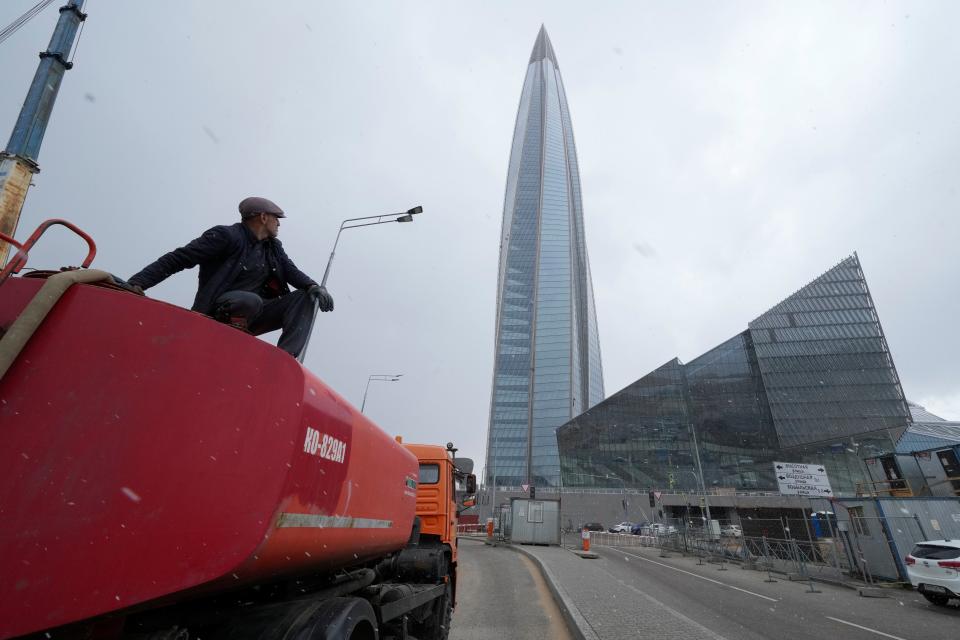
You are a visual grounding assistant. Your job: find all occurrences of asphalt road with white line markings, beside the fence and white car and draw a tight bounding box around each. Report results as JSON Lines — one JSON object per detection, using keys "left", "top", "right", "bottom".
{"left": 581, "top": 547, "right": 960, "bottom": 640}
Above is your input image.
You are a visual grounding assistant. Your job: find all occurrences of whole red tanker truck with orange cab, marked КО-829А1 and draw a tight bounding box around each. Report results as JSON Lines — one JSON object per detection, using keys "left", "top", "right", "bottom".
{"left": 0, "top": 221, "right": 476, "bottom": 640}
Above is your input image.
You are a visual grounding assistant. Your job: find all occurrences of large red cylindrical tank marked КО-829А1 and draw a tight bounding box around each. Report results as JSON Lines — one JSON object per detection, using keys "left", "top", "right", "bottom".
{"left": 0, "top": 278, "right": 418, "bottom": 638}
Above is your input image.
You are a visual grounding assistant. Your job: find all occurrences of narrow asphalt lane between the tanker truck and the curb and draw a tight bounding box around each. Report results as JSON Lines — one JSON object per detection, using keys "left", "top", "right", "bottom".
{"left": 450, "top": 540, "right": 571, "bottom": 640}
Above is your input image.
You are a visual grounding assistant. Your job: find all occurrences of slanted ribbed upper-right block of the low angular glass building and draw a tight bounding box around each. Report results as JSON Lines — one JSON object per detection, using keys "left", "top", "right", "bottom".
{"left": 749, "top": 254, "right": 910, "bottom": 447}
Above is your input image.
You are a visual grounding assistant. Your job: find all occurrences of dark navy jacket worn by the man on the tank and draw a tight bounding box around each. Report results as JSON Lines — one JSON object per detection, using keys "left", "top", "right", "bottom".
{"left": 129, "top": 222, "right": 316, "bottom": 314}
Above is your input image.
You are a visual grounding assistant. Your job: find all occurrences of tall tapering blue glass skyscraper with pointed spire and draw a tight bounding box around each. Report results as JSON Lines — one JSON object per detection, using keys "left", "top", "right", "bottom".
{"left": 487, "top": 22, "right": 603, "bottom": 487}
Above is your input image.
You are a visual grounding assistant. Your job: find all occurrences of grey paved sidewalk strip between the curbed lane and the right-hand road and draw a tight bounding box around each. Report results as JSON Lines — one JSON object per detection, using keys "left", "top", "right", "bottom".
{"left": 513, "top": 545, "right": 722, "bottom": 640}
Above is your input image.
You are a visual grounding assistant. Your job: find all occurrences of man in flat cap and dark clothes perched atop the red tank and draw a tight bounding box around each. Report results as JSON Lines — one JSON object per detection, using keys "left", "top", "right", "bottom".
{"left": 129, "top": 197, "right": 333, "bottom": 357}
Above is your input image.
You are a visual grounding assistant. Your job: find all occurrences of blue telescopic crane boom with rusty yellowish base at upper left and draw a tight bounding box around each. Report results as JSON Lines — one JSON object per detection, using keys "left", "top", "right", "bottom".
{"left": 0, "top": 0, "right": 87, "bottom": 265}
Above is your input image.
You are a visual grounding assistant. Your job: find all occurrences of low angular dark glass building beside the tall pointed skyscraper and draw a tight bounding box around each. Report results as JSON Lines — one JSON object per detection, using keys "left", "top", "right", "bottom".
{"left": 557, "top": 254, "right": 911, "bottom": 495}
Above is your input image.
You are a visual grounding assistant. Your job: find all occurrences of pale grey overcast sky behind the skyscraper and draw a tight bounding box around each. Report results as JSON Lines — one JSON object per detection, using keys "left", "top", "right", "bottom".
{"left": 0, "top": 0, "right": 960, "bottom": 471}
